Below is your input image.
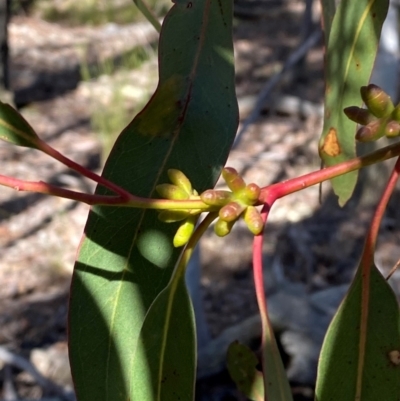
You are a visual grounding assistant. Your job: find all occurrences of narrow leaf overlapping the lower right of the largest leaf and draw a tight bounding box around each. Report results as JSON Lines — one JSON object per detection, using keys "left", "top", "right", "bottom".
{"left": 131, "top": 275, "right": 196, "bottom": 401}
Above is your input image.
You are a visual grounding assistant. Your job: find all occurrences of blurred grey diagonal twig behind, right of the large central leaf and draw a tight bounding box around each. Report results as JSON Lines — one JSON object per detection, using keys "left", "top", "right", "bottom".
{"left": 232, "top": 29, "right": 321, "bottom": 149}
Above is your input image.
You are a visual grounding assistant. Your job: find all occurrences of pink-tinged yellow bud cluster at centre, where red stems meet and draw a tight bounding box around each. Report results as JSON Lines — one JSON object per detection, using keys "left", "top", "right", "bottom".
{"left": 200, "top": 167, "right": 264, "bottom": 237}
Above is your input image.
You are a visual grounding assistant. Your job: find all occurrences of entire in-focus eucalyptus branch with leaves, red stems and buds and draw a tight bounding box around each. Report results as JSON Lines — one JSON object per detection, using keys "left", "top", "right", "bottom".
{"left": 0, "top": 0, "right": 400, "bottom": 401}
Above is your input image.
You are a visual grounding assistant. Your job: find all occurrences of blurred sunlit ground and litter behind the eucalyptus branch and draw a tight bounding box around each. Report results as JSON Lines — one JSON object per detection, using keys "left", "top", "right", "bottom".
{"left": 0, "top": 0, "right": 400, "bottom": 401}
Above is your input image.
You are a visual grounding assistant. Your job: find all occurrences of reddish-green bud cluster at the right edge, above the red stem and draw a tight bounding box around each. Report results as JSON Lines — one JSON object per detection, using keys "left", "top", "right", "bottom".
{"left": 343, "top": 84, "right": 400, "bottom": 142}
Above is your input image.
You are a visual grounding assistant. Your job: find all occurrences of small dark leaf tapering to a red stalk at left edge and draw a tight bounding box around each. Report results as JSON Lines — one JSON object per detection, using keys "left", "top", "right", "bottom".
{"left": 0, "top": 102, "right": 41, "bottom": 149}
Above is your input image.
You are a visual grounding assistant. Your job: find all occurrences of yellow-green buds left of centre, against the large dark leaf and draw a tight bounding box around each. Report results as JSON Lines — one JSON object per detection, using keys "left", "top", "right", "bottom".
{"left": 156, "top": 169, "right": 201, "bottom": 247}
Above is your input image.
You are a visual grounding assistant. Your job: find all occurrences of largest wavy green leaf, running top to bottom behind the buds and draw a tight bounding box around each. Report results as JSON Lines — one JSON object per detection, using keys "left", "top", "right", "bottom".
{"left": 69, "top": 0, "right": 238, "bottom": 401}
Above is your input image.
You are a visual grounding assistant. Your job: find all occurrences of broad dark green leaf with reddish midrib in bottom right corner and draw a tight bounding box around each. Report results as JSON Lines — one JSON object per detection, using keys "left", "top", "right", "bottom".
{"left": 316, "top": 266, "right": 400, "bottom": 401}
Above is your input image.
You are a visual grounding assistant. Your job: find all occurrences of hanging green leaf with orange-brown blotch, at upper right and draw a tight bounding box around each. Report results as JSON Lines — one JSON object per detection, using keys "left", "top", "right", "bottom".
{"left": 319, "top": 0, "right": 389, "bottom": 205}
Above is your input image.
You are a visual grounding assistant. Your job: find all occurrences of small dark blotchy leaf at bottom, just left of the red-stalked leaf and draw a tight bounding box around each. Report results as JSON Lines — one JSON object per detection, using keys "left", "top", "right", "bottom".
{"left": 226, "top": 341, "right": 264, "bottom": 401}
